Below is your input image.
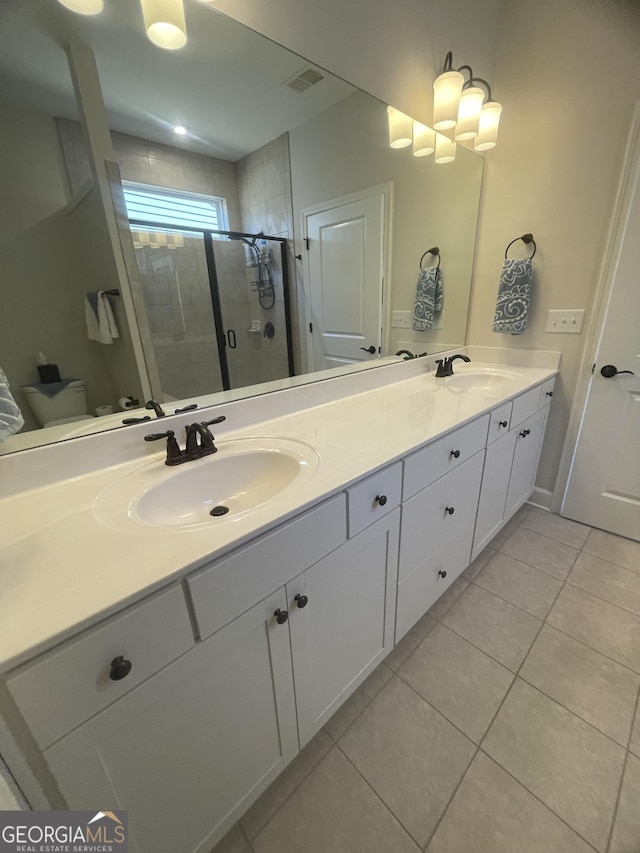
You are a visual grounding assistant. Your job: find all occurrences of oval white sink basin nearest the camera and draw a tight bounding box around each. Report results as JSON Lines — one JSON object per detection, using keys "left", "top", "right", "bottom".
{"left": 94, "top": 438, "right": 318, "bottom": 531}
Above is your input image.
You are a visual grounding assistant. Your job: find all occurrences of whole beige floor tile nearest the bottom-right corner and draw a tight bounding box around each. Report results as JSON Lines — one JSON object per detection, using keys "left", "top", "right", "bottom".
{"left": 483, "top": 679, "right": 625, "bottom": 851}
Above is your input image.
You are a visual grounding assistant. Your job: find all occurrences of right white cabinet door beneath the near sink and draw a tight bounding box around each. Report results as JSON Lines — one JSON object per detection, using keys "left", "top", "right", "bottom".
{"left": 287, "top": 509, "right": 400, "bottom": 747}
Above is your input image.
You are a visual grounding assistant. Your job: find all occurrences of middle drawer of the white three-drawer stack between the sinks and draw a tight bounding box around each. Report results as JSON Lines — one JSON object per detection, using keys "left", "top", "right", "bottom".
{"left": 398, "top": 451, "right": 484, "bottom": 579}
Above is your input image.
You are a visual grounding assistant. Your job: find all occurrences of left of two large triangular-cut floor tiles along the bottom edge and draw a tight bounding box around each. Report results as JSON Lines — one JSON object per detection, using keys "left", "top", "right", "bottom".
{"left": 253, "top": 747, "right": 419, "bottom": 853}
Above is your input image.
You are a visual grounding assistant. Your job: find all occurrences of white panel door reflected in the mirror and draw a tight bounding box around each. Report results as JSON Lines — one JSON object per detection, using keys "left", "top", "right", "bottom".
{"left": 302, "top": 190, "right": 385, "bottom": 370}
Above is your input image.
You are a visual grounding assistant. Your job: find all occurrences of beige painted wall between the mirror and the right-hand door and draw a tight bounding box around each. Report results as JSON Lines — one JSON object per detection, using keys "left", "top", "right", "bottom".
{"left": 468, "top": 0, "right": 640, "bottom": 500}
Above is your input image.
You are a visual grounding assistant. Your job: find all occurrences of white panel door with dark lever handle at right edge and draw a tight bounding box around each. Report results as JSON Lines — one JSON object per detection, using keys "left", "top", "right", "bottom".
{"left": 562, "top": 117, "right": 640, "bottom": 540}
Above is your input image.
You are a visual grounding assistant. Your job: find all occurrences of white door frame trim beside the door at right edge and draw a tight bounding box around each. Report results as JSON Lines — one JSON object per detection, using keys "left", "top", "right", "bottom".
{"left": 551, "top": 101, "right": 640, "bottom": 513}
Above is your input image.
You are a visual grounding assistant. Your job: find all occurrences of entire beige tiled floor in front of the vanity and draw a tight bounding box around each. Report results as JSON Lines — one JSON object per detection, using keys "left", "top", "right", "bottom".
{"left": 214, "top": 507, "right": 640, "bottom": 853}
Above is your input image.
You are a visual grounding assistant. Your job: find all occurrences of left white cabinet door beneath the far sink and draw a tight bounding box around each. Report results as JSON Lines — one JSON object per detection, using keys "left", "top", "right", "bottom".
{"left": 471, "top": 429, "right": 518, "bottom": 560}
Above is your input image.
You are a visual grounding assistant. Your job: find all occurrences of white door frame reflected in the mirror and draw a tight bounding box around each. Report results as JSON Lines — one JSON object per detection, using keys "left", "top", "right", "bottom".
{"left": 300, "top": 181, "right": 393, "bottom": 373}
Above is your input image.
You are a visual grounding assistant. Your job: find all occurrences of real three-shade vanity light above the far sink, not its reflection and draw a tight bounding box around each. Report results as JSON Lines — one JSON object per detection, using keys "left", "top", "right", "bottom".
{"left": 433, "top": 51, "right": 502, "bottom": 151}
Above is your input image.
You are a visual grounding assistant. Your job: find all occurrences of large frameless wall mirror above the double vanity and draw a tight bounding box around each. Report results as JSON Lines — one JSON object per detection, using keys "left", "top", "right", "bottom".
{"left": 0, "top": 0, "right": 483, "bottom": 453}
